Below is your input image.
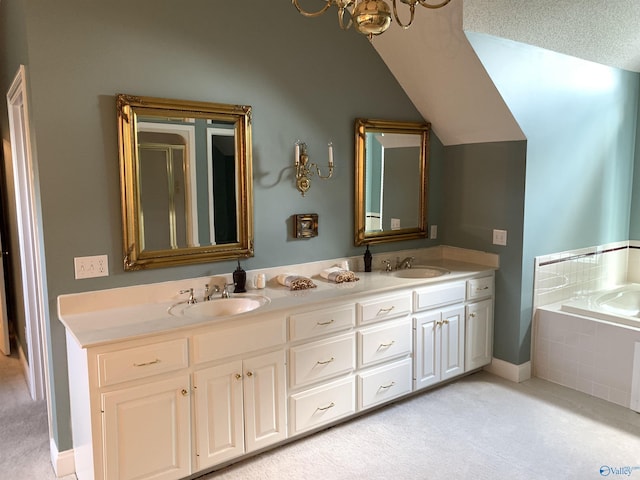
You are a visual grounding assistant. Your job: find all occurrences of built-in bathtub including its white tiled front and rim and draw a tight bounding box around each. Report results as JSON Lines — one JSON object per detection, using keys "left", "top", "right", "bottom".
{"left": 532, "top": 284, "right": 640, "bottom": 412}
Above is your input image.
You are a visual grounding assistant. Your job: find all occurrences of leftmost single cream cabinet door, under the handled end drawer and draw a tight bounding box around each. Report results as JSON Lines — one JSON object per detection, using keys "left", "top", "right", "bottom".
{"left": 102, "top": 375, "right": 191, "bottom": 480}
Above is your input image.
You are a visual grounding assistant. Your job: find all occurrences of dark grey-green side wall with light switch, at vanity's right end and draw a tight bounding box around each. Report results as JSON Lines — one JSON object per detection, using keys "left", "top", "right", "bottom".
{"left": 441, "top": 141, "right": 527, "bottom": 363}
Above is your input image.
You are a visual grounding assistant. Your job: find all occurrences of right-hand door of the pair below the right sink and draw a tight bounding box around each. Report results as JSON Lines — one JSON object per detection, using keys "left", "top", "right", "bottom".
{"left": 440, "top": 307, "right": 465, "bottom": 380}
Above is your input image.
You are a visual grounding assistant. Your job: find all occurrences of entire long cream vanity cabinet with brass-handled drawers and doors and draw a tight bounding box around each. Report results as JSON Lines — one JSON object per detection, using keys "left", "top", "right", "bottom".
{"left": 61, "top": 262, "right": 494, "bottom": 480}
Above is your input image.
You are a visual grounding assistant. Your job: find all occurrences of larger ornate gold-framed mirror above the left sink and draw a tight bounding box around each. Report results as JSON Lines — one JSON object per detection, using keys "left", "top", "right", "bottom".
{"left": 117, "top": 94, "right": 253, "bottom": 270}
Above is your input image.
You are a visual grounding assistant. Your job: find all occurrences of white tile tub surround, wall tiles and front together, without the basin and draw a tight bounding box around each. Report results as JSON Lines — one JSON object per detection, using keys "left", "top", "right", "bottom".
{"left": 531, "top": 241, "right": 640, "bottom": 408}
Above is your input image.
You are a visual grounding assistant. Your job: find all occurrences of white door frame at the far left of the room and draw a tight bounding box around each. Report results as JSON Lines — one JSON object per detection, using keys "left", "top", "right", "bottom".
{"left": 7, "top": 65, "right": 51, "bottom": 408}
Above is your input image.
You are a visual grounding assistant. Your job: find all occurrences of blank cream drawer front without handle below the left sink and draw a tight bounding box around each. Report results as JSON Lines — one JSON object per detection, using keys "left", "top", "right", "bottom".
{"left": 192, "top": 316, "right": 287, "bottom": 364}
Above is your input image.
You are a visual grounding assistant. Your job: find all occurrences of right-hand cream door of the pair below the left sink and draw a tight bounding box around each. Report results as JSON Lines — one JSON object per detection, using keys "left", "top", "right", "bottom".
{"left": 243, "top": 350, "right": 287, "bottom": 452}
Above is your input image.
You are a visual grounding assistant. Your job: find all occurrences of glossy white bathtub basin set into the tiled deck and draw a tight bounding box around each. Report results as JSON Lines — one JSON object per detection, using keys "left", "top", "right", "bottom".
{"left": 560, "top": 283, "right": 640, "bottom": 328}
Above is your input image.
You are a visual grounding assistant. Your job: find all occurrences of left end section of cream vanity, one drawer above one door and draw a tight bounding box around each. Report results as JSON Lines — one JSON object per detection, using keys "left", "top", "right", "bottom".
{"left": 67, "top": 333, "right": 191, "bottom": 480}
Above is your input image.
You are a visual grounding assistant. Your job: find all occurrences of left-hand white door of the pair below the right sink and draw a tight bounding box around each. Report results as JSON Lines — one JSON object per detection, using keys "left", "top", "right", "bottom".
{"left": 413, "top": 312, "right": 440, "bottom": 390}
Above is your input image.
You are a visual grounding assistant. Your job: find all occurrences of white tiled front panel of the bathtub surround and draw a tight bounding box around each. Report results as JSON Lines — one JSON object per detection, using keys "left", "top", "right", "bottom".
{"left": 534, "top": 306, "right": 640, "bottom": 408}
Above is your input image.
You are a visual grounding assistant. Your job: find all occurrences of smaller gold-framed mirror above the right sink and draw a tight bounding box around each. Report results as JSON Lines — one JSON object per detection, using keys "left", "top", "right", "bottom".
{"left": 354, "top": 118, "right": 431, "bottom": 245}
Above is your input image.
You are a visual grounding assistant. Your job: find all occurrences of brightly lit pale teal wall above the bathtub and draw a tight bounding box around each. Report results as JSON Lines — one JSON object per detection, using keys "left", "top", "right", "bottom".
{"left": 467, "top": 32, "right": 639, "bottom": 364}
